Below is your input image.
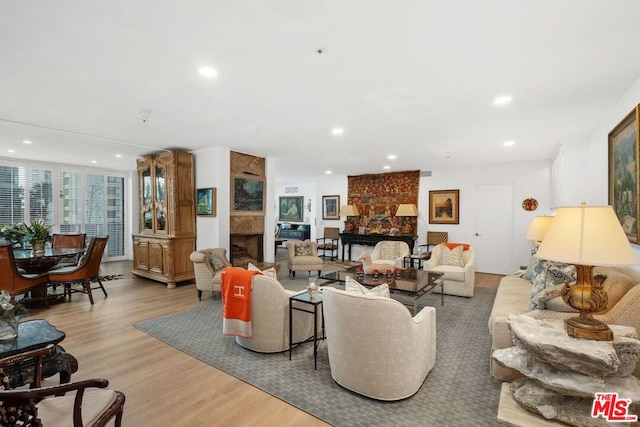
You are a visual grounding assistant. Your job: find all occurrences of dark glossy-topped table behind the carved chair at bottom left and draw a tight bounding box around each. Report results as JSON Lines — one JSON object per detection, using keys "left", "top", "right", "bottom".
{"left": 0, "top": 319, "right": 78, "bottom": 388}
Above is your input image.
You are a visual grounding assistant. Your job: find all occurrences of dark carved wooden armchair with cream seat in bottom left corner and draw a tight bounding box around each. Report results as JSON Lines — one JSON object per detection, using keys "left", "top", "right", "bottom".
{"left": 0, "top": 344, "right": 125, "bottom": 427}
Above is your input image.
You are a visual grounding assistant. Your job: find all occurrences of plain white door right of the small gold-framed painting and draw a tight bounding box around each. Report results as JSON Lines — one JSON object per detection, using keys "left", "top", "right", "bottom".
{"left": 474, "top": 184, "right": 517, "bottom": 274}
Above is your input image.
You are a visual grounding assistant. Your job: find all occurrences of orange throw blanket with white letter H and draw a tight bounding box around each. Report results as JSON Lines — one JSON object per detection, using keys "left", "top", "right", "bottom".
{"left": 220, "top": 267, "right": 262, "bottom": 338}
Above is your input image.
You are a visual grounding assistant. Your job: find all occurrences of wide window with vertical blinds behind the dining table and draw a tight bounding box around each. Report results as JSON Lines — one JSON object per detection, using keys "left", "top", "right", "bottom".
{"left": 0, "top": 159, "right": 126, "bottom": 259}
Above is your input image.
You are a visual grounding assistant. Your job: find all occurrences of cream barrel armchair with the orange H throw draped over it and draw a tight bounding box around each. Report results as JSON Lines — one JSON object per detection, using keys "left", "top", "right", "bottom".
{"left": 236, "top": 274, "right": 313, "bottom": 353}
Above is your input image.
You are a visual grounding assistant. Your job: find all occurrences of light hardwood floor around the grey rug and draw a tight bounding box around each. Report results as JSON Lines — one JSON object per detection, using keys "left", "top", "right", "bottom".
{"left": 30, "top": 262, "right": 502, "bottom": 427}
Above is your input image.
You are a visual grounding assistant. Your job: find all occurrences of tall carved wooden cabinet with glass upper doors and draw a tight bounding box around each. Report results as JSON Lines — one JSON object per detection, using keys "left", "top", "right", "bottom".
{"left": 133, "top": 151, "right": 196, "bottom": 288}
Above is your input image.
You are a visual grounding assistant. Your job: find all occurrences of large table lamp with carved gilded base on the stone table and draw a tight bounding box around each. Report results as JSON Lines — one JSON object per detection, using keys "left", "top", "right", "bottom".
{"left": 536, "top": 203, "right": 638, "bottom": 341}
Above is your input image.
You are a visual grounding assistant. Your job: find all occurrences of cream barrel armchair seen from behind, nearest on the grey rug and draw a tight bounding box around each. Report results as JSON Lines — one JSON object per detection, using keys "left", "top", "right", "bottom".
{"left": 322, "top": 287, "right": 436, "bottom": 400}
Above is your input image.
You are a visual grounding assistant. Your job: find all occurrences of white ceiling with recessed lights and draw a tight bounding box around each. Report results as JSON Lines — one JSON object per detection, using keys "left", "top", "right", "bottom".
{"left": 0, "top": 0, "right": 640, "bottom": 180}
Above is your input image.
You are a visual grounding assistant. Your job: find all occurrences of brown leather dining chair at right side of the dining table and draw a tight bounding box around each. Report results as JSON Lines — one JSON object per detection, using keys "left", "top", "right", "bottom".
{"left": 49, "top": 236, "right": 109, "bottom": 304}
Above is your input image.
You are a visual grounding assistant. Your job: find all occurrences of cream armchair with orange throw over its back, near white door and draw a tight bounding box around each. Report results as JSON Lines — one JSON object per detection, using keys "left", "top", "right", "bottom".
{"left": 424, "top": 243, "right": 476, "bottom": 297}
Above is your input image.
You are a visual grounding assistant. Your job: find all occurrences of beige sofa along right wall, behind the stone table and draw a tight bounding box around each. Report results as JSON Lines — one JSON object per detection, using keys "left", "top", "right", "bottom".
{"left": 489, "top": 267, "right": 640, "bottom": 381}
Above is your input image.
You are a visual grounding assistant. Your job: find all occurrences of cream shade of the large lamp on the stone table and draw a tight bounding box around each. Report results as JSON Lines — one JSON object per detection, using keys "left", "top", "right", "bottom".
{"left": 537, "top": 204, "right": 638, "bottom": 266}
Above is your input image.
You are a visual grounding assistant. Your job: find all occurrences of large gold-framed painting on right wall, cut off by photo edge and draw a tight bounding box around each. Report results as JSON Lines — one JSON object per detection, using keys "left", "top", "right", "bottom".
{"left": 609, "top": 105, "right": 640, "bottom": 244}
